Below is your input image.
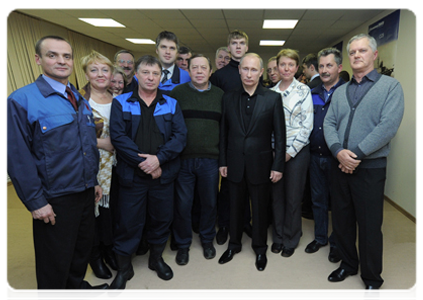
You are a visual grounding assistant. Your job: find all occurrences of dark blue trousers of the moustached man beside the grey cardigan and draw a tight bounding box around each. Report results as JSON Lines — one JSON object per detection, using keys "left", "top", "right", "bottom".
{"left": 310, "top": 154, "right": 336, "bottom": 247}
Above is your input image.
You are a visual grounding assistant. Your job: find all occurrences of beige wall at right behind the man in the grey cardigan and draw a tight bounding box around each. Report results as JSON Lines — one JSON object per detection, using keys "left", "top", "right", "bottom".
{"left": 328, "top": 8, "right": 420, "bottom": 220}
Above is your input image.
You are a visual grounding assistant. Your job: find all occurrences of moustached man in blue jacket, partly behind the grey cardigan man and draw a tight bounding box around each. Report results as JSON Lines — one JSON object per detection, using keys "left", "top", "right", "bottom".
{"left": 305, "top": 48, "right": 345, "bottom": 263}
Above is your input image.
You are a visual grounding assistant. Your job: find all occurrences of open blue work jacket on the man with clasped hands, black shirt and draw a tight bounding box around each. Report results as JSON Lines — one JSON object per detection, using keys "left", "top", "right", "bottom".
{"left": 110, "top": 89, "right": 187, "bottom": 186}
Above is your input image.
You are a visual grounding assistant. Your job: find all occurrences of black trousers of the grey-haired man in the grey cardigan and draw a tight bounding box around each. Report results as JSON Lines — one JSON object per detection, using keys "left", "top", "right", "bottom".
{"left": 330, "top": 161, "right": 386, "bottom": 287}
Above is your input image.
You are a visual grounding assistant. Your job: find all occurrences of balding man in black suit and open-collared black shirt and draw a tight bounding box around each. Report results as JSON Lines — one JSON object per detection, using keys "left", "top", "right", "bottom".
{"left": 219, "top": 53, "right": 286, "bottom": 271}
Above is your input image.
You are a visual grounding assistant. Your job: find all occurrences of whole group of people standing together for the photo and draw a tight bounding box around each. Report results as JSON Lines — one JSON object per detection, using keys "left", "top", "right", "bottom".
{"left": 6, "top": 30, "right": 404, "bottom": 300}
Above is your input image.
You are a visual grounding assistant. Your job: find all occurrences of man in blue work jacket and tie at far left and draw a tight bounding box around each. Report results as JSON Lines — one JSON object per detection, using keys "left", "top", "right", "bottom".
{"left": 5, "top": 36, "right": 109, "bottom": 300}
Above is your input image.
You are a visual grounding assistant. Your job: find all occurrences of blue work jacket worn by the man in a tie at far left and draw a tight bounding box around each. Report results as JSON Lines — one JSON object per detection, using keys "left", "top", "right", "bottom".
{"left": 5, "top": 76, "right": 99, "bottom": 211}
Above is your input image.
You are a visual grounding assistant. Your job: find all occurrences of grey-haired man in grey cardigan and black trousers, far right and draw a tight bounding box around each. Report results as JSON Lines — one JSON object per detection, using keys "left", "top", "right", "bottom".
{"left": 324, "top": 34, "right": 404, "bottom": 300}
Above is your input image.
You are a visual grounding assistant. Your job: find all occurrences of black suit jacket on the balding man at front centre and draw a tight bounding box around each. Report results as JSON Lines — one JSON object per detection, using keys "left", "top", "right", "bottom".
{"left": 219, "top": 84, "right": 286, "bottom": 184}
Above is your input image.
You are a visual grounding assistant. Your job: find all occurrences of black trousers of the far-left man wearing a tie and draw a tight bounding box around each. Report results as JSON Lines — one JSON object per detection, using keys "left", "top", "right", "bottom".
{"left": 33, "top": 188, "right": 94, "bottom": 300}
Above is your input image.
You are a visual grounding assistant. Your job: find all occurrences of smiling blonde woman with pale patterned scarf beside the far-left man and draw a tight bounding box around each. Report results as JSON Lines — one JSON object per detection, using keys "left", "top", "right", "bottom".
{"left": 80, "top": 51, "right": 117, "bottom": 279}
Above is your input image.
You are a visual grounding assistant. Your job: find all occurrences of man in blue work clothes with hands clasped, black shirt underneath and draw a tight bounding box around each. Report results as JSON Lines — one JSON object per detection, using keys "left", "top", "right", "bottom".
{"left": 108, "top": 55, "right": 187, "bottom": 297}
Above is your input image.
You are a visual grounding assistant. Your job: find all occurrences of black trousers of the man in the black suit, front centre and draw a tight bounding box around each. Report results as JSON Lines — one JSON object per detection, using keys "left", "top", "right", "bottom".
{"left": 228, "top": 176, "right": 270, "bottom": 254}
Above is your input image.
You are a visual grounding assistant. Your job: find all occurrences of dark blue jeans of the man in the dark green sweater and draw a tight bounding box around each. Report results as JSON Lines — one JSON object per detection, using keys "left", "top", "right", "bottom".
{"left": 172, "top": 158, "right": 219, "bottom": 249}
